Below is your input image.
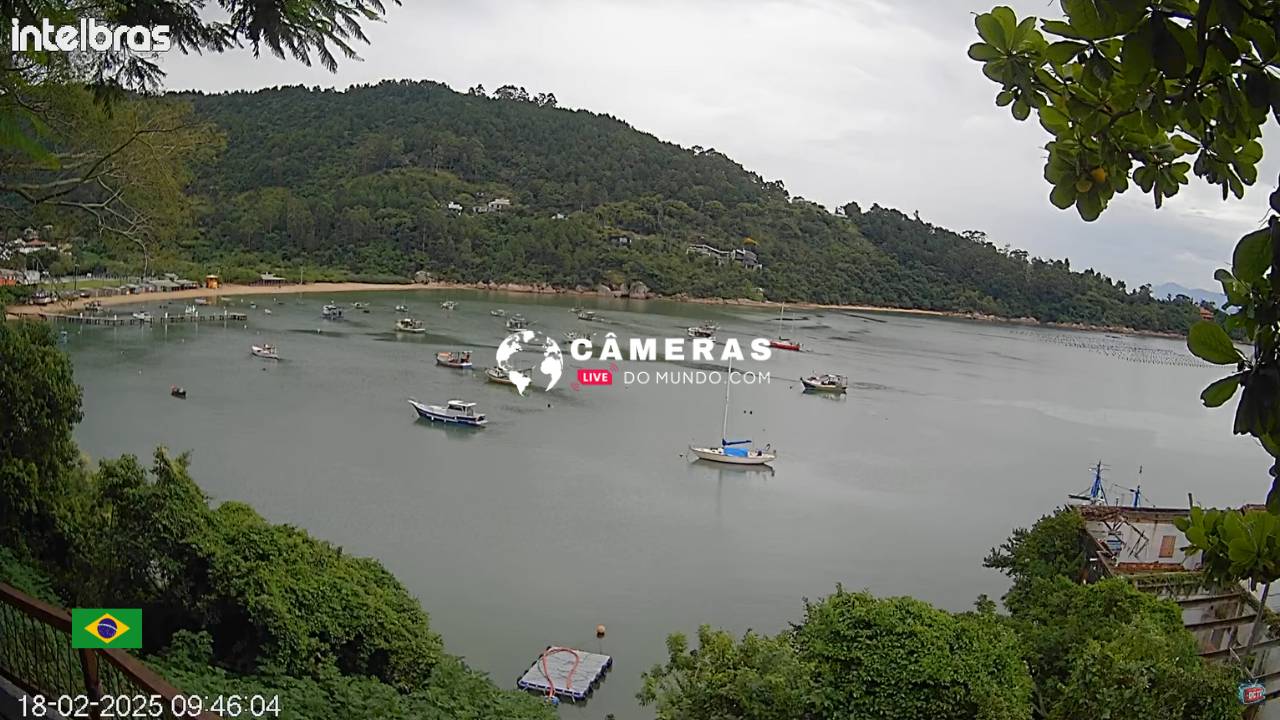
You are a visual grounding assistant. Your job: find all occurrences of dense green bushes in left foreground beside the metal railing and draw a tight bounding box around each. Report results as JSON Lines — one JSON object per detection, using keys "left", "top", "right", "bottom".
{"left": 0, "top": 322, "right": 553, "bottom": 720}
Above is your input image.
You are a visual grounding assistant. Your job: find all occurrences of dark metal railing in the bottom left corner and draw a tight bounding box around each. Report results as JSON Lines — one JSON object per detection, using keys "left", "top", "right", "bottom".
{"left": 0, "top": 583, "right": 218, "bottom": 720}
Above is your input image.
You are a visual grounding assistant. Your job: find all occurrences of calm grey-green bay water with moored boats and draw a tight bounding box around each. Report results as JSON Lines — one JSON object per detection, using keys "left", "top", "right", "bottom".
{"left": 67, "top": 292, "right": 1268, "bottom": 720}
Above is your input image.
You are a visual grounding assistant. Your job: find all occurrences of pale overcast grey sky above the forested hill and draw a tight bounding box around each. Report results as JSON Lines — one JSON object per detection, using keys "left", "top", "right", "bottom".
{"left": 154, "top": 0, "right": 1280, "bottom": 290}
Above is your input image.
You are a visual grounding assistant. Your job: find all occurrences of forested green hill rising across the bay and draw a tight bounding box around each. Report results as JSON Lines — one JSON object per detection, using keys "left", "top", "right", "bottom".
{"left": 177, "top": 81, "right": 1198, "bottom": 331}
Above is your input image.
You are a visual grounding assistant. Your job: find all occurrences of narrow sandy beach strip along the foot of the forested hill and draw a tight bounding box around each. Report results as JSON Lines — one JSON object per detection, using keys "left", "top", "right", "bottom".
{"left": 5, "top": 282, "right": 1183, "bottom": 338}
